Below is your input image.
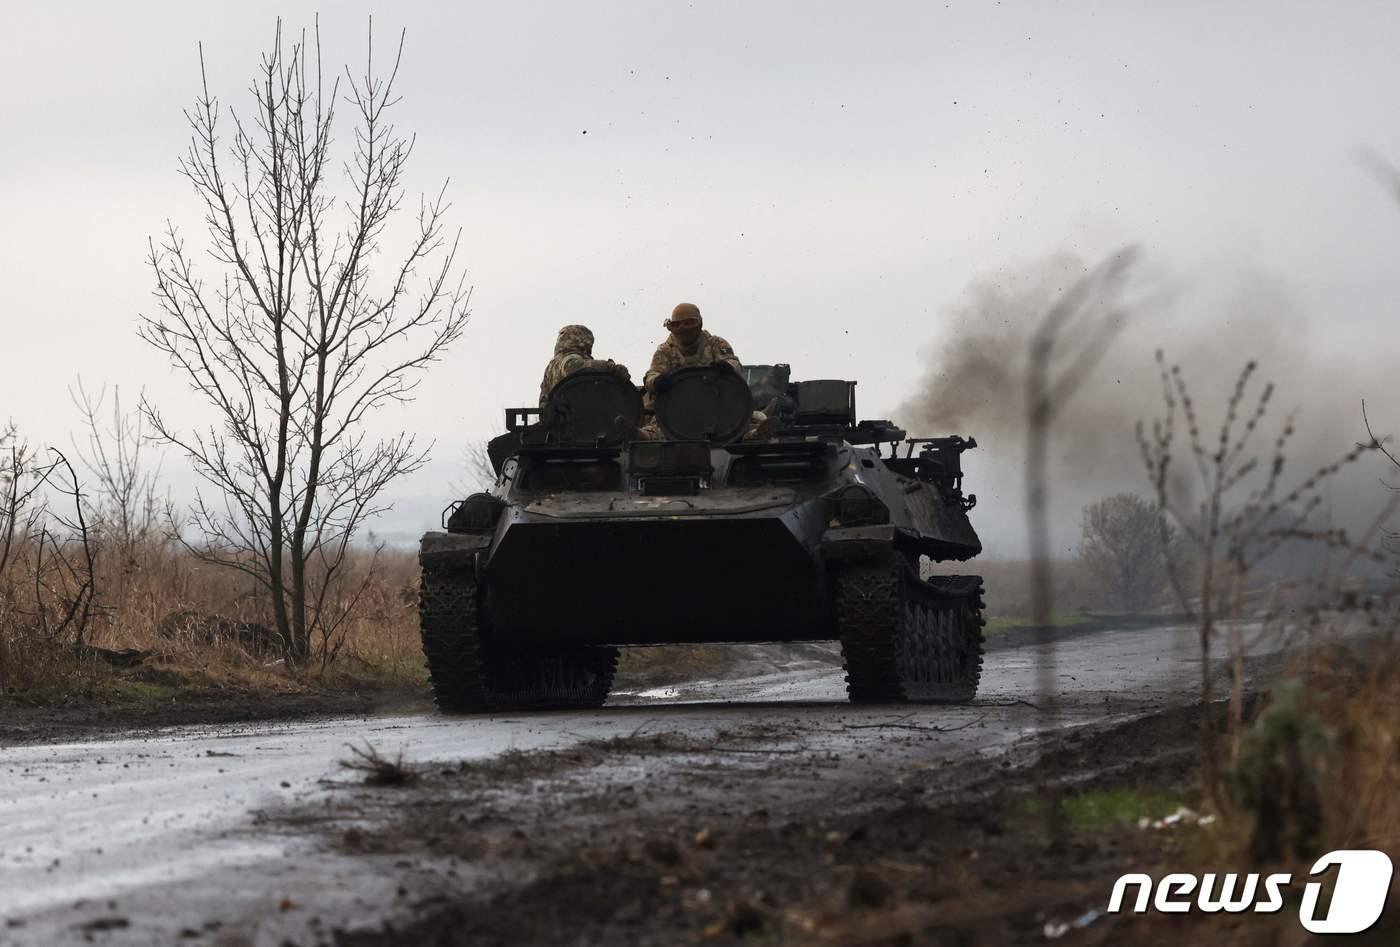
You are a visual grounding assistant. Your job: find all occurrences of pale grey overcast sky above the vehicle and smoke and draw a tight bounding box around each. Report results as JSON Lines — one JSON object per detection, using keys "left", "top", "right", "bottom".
{"left": 0, "top": 0, "right": 1400, "bottom": 553}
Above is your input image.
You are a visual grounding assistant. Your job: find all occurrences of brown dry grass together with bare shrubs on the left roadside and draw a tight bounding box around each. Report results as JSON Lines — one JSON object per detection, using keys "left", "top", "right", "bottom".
{"left": 0, "top": 369, "right": 423, "bottom": 710}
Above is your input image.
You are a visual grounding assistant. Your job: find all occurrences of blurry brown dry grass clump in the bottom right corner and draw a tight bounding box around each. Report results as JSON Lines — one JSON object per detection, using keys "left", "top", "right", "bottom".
{"left": 1152, "top": 615, "right": 1400, "bottom": 944}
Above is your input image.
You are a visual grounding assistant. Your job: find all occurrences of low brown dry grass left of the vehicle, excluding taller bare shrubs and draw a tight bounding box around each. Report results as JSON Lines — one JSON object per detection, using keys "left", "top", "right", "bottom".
{"left": 0, "top": 509, "right": 424, "bottom": 712}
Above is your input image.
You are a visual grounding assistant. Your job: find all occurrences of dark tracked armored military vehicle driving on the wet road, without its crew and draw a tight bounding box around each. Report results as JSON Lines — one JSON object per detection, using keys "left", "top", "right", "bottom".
{"left": 420, "top": 364, "right": 983, "bottom": 713}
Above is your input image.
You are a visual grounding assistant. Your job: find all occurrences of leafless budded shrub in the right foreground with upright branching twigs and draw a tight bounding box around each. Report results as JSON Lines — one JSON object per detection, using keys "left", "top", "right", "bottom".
{"left": 1138, "top": 353, "right": 1396, "bottom": 811}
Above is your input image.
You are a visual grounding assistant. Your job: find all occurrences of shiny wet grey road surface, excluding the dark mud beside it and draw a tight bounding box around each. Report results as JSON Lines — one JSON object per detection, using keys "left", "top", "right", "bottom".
{"left": 0, "top": 628, "right": 1197, "bottom": 944}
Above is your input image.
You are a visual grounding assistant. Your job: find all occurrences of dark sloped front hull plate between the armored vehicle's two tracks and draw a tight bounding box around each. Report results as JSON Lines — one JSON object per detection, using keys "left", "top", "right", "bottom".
{"left": 482, "top": 510, "right": 834, "bottom": 647}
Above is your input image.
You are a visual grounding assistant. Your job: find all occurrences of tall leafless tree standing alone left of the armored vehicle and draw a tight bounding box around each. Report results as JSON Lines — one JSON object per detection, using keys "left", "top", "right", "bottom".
{"left": 140, "top": 21, "right": 470, "bottom": 661}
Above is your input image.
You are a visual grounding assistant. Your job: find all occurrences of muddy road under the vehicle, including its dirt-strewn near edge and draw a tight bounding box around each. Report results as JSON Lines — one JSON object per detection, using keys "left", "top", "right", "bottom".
{"left": 0, "top": 628, "right": 1196, "bottom": 944}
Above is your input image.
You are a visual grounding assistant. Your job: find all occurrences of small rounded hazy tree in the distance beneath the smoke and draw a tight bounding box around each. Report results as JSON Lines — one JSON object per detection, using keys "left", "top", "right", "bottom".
{"left": 1079, "top": 493, "right": 1177, "bottom": 611}
